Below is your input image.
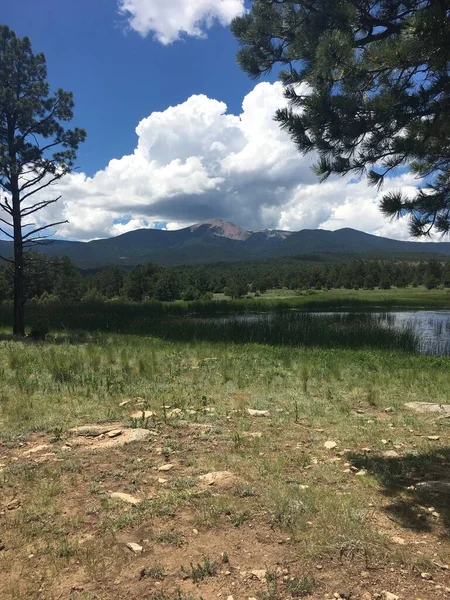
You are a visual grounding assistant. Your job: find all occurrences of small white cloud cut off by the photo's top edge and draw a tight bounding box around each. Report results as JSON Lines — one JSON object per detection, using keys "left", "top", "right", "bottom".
{"left": 118, "top": 0, "right": 245, "bottom": 44}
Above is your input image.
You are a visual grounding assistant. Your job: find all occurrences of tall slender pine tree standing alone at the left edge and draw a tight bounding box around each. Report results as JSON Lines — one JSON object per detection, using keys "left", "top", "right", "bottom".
{"left": 0, "top": 25, "right": 86, "bottom": 336}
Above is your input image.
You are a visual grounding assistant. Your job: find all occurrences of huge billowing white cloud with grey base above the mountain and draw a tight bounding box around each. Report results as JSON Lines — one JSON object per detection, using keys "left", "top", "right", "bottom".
{"left": 21, "top": 82, "right": 417, "bottom": 240}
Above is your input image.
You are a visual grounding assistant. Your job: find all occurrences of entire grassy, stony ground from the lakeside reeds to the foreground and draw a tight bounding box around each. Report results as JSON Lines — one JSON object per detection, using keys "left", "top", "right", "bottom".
{"left": 0, "top": 291, "right": 450, "bottom": 600}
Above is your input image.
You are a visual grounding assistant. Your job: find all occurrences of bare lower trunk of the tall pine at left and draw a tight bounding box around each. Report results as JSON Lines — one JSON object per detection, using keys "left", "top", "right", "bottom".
{"left": 12, "top": 189, "right": 25, "bottom": 337}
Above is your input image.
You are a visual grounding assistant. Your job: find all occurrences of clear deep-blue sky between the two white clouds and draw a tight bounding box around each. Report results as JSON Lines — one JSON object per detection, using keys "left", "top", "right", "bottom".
{"left": 1, "top": 0, "right": 254, "bottom": 175}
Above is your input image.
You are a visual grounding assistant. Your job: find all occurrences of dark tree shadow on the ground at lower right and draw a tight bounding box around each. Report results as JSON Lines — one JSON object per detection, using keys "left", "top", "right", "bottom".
{"left": 347, "top": 448, "right": 450, "bottom": 533}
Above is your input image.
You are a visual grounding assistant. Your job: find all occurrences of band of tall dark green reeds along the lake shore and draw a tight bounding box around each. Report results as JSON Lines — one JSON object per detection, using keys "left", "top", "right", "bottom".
{"left": 0, "top": 301, "right": 418, "bottom": 352}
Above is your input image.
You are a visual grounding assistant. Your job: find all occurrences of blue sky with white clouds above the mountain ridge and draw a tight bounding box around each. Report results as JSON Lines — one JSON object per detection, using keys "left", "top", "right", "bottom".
{"left": 1, "top": 0, "right": 418, "bottom": 240}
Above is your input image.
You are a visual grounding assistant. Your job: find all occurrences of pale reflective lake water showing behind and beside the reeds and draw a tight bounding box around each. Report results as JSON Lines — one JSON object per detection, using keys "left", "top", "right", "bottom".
{"left": 215, "top": 310, "right": 450, "bottom": 356}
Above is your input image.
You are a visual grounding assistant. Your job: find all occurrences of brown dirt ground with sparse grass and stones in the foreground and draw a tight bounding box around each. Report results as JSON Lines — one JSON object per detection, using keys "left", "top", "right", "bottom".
{"left": 0, "top": 406, "right": 450, "bottom": 600}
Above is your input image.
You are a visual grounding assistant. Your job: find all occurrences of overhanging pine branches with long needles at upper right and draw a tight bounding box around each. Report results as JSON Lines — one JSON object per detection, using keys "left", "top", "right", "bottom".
{"left": 232, "top": 0, "right": 450, "bottom": 236}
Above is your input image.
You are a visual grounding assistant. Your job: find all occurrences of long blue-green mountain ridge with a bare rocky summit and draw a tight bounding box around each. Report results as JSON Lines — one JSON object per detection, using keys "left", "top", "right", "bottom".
{"left": 0, "top": 219, "right": 450, "bottom": 268}
